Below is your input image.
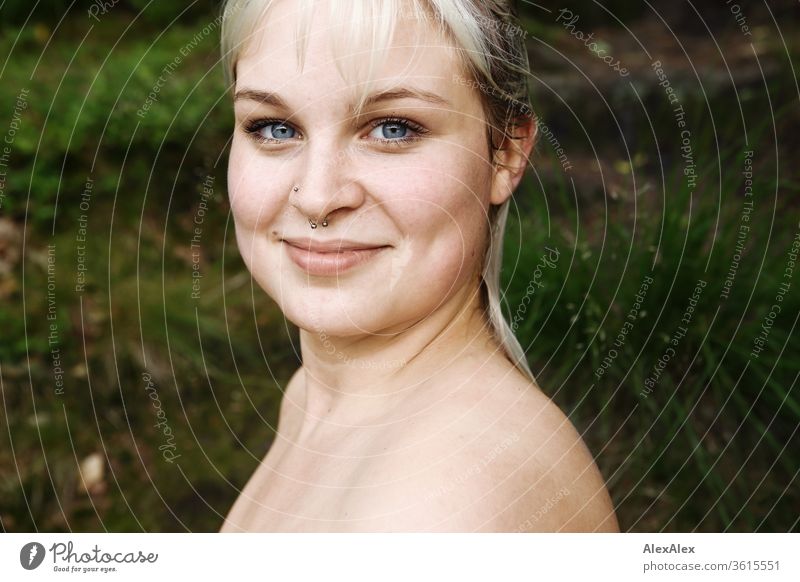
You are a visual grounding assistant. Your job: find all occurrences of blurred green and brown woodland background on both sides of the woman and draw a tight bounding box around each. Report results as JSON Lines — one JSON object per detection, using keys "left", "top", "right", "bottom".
{"left": 0, "top": 0, "right": 800, "bottom": 531}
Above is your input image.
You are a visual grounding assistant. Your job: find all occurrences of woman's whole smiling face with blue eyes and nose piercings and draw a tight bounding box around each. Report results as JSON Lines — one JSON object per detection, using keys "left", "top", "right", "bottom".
{"left": 228, "top": 1, "right": 493, "bottom": 336}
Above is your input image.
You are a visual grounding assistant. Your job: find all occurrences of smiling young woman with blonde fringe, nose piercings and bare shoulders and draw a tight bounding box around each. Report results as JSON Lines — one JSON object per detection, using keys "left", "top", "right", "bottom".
{"left": 216, "top": 0, "right": 618, "bottom": 532}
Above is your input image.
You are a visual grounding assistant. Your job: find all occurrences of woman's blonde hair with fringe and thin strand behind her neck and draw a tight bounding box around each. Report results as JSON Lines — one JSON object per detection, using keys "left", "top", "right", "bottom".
{"left": 221, "top": 0, "right": 535, "bottom": 381}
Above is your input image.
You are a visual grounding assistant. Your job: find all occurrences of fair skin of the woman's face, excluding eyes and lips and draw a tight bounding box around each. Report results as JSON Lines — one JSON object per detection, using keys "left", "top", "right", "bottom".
{"left": 228, "top": 15, "right": 492, "bottom": 335}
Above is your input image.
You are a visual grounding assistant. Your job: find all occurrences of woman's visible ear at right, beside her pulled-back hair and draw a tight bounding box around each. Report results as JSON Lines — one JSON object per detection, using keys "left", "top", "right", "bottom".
{"left": 490, "top": 116, "right": 537, "bottom": 205}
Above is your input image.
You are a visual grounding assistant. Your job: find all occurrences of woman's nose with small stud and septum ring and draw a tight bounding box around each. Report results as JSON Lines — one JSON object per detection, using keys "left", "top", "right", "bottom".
{"left": 289, "top": 142, "right": 365, "bottom": 223}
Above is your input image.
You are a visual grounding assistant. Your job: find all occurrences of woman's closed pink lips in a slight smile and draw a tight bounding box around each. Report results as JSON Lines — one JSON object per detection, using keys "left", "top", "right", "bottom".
{"left": 282, "top": 239, "right": 389, "bottom": 277}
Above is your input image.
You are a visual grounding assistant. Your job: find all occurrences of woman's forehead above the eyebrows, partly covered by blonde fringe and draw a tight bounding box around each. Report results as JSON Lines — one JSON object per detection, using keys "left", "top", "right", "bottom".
{"left": 236, "top": 0, "right": 468, "bottom": 106}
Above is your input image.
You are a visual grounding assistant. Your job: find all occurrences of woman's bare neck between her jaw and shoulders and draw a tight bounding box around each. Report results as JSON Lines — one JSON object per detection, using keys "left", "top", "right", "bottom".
{"left": 299, "top": 286, "right": 503, "bottom": 427}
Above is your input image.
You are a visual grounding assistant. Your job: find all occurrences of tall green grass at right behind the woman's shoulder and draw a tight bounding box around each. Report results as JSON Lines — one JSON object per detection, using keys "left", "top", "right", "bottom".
{"left": 505, "top": 124, "right": 800, "bottom": 531}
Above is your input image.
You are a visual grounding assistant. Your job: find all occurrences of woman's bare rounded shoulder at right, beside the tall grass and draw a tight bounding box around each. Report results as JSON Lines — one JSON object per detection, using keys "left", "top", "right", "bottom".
{"left": 366, "top": 375, "right": 619, "bottom": 532}
